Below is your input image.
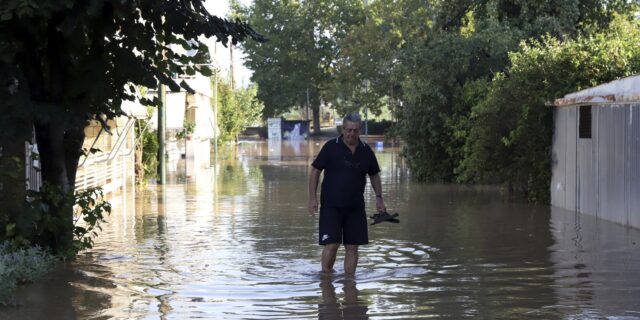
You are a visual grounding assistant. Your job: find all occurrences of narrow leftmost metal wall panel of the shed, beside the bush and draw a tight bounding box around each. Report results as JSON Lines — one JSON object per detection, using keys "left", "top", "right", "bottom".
{"left": 550, "top": 108, "right": 570, "bottom": 208}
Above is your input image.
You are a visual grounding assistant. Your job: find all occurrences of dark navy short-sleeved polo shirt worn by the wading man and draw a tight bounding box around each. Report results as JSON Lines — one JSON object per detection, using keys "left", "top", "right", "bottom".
{"left": 311, "top": 135, "right": 380, "bottom": 208}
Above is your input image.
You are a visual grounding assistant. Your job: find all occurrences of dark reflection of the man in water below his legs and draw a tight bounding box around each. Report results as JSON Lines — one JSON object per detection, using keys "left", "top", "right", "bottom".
{"left": 318, "top": 277, "right": 369, "bottom": 319}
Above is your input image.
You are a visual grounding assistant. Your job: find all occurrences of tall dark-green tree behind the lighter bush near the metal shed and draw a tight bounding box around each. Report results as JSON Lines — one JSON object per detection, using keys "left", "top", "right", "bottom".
{"left": 399, "top": 0, "right": 627, "bottom": 181}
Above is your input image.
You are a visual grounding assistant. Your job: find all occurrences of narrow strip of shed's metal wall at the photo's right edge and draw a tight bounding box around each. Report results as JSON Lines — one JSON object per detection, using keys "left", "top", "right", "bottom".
{"left": 626, "top": 103, "right": 640, "bottom": 228}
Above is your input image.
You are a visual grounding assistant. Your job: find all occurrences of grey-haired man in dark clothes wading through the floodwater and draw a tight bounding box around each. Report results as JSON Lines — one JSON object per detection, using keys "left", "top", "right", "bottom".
{"left": 309, "top": 113, "right": 386, "bottom": 275}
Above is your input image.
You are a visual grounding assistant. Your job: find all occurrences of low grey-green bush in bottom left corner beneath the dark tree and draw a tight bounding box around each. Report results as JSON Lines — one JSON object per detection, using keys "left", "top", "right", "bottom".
{"left": 0, "top": 242, "right": 57, "bottom": 306}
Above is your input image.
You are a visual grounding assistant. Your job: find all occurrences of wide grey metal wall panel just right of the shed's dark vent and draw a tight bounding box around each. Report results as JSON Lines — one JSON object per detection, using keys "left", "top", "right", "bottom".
{"left": 596, "top": 106, "right": 627, "bottom": 224}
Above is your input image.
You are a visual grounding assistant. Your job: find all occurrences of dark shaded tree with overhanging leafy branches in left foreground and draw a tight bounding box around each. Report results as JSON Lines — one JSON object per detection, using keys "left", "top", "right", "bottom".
{"left": 0, "top": 0, "right": 263, "bottom": 254}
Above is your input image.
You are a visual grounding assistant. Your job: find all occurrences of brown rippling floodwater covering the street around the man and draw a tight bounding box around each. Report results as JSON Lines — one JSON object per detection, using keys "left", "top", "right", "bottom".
{"left": 0, "top": 141, "right": 640, "bottom": 319}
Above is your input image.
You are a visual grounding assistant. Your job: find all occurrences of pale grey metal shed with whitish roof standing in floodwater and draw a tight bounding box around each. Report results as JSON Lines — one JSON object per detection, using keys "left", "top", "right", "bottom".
{"left": 551, "top": 75, "right": 640, "bottom": 228}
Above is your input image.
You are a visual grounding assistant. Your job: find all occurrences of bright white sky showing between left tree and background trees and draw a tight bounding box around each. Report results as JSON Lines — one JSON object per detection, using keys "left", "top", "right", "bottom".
{"left": 204, "top": 0, "right": 253, "bottom": 86}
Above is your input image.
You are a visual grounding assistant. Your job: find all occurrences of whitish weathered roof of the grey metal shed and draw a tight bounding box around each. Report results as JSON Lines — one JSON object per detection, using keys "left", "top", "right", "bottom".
{"left": 553, "top": 75, "right": 640, "bottom": 107}
